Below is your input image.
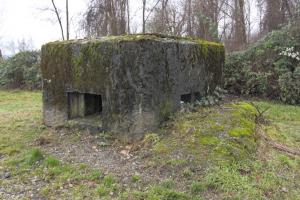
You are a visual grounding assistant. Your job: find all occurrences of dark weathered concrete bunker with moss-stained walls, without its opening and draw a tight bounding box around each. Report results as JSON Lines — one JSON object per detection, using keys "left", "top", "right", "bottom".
{"left": 42, "top": 35, "right": 224, "bottom": 138}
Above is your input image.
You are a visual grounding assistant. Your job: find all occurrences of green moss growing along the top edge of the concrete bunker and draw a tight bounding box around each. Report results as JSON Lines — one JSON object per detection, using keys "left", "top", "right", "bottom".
{"left": 42, "top": 34, "right": 225, "bottom": 72}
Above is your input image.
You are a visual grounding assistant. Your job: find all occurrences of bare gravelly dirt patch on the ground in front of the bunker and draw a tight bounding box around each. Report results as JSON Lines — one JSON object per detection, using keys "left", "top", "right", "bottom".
{"left": 42, "top": 130, "right": 168, "bottom": 186}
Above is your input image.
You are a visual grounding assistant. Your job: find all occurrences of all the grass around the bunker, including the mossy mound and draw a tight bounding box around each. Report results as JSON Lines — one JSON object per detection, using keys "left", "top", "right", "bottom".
{"left": 0, "top": 91, "right": 300, "bottom": 200}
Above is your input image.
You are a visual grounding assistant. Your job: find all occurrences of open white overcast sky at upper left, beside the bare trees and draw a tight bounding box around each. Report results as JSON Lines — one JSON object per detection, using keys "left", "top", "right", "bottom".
{"left": 0, "top": 0, "right": 87, "bottom": 53}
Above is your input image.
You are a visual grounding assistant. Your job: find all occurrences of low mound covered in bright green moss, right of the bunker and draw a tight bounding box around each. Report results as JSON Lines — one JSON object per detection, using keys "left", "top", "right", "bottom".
{"left": 148, "top": 102, "right": 257, "bottom": 165}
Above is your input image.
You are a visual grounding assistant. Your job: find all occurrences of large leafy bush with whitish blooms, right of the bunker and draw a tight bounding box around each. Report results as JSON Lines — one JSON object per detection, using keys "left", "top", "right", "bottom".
{"left": 224, "top": 24, "right": 300, "bottom": 104}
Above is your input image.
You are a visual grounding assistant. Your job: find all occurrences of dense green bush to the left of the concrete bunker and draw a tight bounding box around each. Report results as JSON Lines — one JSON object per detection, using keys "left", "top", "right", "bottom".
{"left": 0, "top": 51, "right": 41, "bottom": 89}
